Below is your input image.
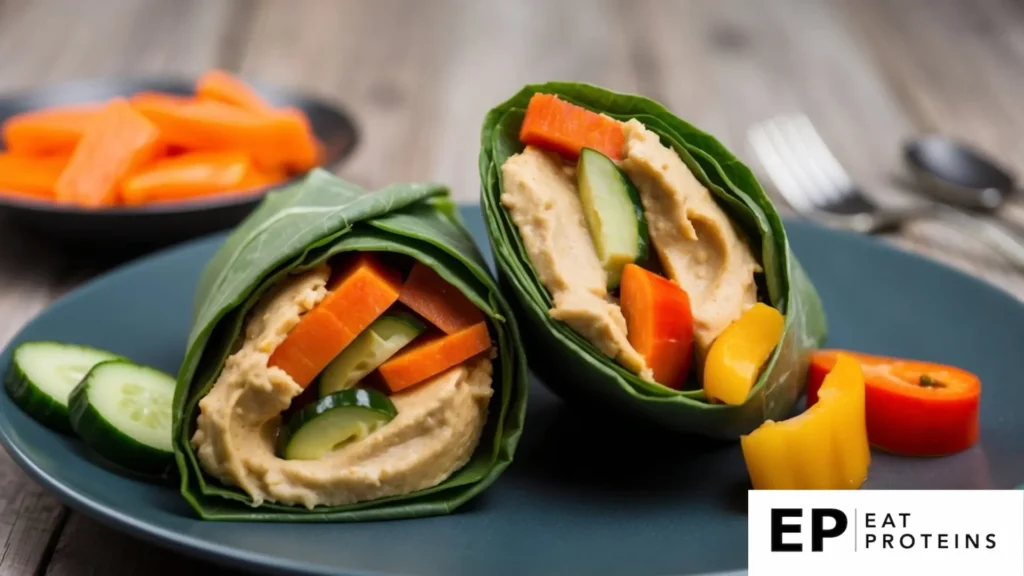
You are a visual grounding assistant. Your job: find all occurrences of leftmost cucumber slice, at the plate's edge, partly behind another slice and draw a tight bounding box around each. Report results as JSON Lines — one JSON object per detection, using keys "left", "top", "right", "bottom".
{"left": 4, "top": 341, "right": 121, "bottom": 433}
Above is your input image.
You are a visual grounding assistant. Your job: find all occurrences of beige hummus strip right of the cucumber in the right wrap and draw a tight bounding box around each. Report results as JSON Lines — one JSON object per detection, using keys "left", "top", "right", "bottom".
{"left": 622, "top": 119, "right": 760, "bottom": 359}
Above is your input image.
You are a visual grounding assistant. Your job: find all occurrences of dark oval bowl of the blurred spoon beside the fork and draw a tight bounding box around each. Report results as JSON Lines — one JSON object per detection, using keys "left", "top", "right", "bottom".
{"left": 903, "top": 134, "right": 1017, "bottom": 212}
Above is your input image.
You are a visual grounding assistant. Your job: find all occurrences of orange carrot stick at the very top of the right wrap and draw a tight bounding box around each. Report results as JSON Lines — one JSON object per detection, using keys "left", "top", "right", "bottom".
{"left": 519, "top": 93, "right": 626, "bottom": 160}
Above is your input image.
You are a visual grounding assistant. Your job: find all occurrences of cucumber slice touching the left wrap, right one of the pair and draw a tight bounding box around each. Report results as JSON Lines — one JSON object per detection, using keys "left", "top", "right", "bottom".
{"left": 69, "top": 360, "right": 175, "bottom": 475}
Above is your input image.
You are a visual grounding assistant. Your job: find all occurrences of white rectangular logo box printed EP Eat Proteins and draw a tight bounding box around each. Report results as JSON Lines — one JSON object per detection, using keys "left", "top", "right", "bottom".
{"left": 748, "top": 490, "right": 1024, "bottom": 576}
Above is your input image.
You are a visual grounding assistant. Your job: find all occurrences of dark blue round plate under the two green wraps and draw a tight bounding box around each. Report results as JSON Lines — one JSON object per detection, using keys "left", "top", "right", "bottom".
{"left": 0, "top": 207, "right": 1024, "bottom": 576}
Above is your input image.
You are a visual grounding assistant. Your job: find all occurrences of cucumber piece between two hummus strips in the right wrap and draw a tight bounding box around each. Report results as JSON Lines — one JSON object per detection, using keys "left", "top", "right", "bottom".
{"left": 577, "top": 143, "right": 650, "bottom": 290}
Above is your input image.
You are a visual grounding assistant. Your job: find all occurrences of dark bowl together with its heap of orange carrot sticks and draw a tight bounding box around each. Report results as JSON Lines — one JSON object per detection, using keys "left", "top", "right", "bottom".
{"left": 0, "top": 70, "right": 357, "bottom": 244}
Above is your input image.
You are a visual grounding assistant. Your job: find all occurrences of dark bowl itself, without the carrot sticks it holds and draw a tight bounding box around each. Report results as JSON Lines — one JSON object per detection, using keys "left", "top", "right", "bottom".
{"left": 0, "top": 78, "right": 358, "bottom": 247}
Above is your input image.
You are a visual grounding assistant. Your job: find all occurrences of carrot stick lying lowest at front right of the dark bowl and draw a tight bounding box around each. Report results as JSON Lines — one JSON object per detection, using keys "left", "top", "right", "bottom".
{"left": 121, "top": 152, "right": 255, "bottom": 205}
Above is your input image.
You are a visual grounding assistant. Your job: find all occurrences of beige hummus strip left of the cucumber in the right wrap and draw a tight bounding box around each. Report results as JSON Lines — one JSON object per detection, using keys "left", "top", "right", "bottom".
{"left": 502, "top": 147, "right": 653, "bottom": 380}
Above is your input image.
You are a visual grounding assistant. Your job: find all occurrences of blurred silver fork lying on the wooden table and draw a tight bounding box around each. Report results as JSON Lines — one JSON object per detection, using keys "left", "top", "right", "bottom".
{"left": 748, "top": 115, "right": 1024, "bottom": 269}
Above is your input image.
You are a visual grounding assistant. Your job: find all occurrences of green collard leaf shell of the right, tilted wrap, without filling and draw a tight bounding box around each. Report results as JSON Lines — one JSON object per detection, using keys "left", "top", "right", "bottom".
{"left": 479, "top": 82, "right": 826, "bottom": 439}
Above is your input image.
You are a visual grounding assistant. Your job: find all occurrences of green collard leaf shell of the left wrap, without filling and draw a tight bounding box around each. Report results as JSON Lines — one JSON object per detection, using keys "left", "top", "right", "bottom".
{"left": 173, "top": 170, "right": 527, "bottom": 522}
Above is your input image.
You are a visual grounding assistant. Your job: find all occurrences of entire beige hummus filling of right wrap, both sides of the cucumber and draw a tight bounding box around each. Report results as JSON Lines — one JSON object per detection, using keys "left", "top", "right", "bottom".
{"left": 501, "top": 119, "right": 761, "bottom": 380}
